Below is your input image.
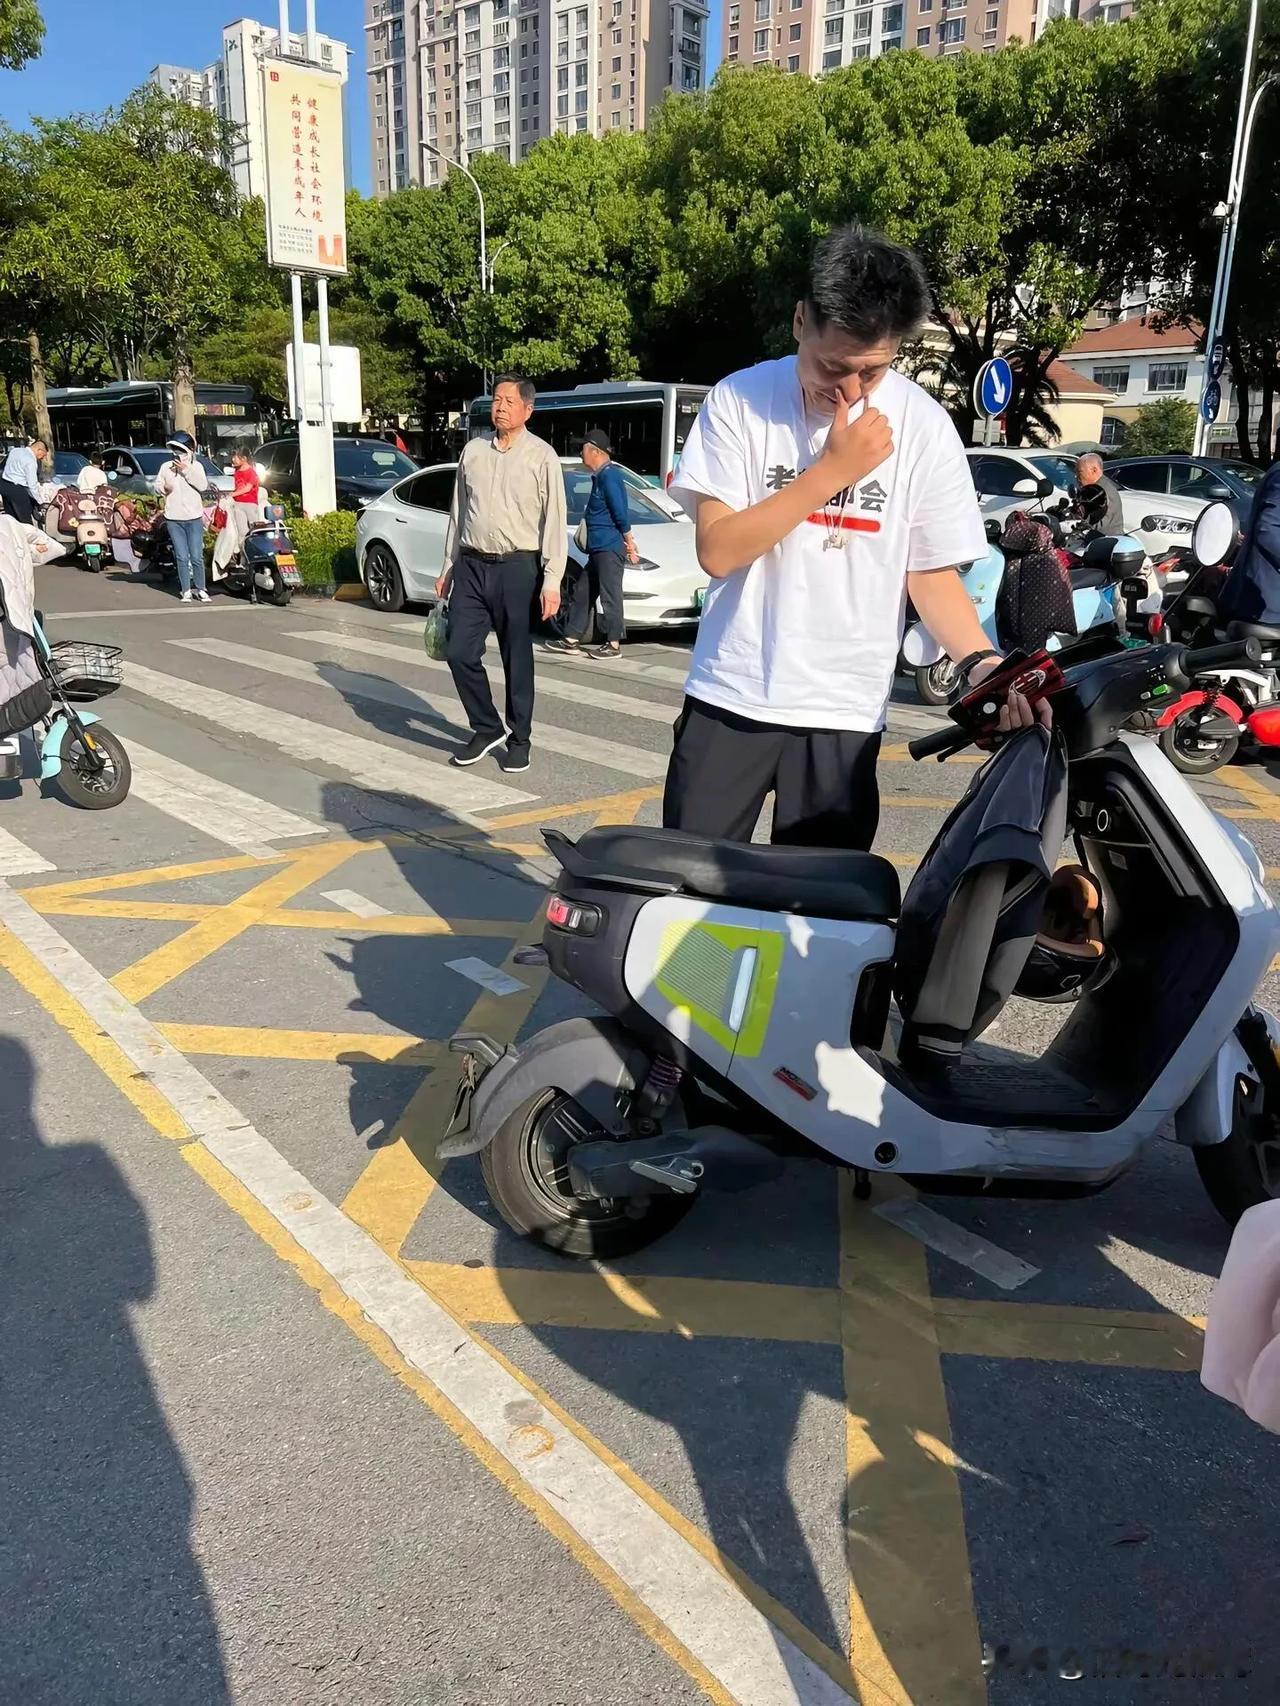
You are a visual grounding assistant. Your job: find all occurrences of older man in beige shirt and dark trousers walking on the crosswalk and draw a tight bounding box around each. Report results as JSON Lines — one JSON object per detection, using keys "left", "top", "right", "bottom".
{"left": 435, "top": 374, "right": 568, "bottom": 773}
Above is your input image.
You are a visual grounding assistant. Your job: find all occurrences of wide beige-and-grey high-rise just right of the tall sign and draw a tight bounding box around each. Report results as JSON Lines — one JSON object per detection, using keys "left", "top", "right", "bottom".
{"left": 365, "top": 0, "right": 708, "bottom": 196}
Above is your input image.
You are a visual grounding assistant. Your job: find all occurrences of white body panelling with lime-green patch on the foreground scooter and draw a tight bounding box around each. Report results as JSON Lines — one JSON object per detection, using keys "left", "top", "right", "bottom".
{"left": 623, "top": 735, "right": 1280, "bottom": 1181}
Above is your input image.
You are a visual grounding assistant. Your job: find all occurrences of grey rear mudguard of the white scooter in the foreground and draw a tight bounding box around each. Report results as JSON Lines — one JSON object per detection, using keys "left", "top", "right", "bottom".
{"left": 447, "top": 1018, "right": 649, "bottom": 1160}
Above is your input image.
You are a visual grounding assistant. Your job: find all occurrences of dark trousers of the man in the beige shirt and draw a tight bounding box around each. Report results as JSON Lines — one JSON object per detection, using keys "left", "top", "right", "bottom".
{"left": 449, "top": 551, "right": 541, "bottom": 746}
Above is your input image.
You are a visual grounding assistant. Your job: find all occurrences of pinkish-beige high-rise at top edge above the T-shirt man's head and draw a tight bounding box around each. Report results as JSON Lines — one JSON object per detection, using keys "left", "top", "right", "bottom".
{"left": 722, "top": 0, "right": 1135, "bottom": 77}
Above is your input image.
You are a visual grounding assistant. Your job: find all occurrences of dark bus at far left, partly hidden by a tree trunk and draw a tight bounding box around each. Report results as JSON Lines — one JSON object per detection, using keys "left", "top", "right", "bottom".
{"left": 49, "top": 379, "right": 273, "bottom": 467}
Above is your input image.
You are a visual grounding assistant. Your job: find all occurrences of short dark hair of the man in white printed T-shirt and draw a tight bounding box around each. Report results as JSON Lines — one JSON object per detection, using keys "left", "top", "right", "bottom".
{"left": 806, "top": 225, "right": 930, "bottom": 345}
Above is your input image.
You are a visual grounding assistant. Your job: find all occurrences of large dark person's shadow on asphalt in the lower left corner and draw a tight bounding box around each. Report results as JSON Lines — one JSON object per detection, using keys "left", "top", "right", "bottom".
{"left": 0, "top": 1036, "right": 232, "bottom": 1706}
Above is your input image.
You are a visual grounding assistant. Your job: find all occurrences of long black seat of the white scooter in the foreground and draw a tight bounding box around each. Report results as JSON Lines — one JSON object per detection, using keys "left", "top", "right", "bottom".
{"left": 570, "top": 826, "right": 901, "bottom": 920}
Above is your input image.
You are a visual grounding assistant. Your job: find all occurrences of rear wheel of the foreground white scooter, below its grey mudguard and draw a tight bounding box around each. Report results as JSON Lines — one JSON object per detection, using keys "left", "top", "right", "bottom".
{"left": 480, "top": 1090, "right": 696, "bottom": 1261}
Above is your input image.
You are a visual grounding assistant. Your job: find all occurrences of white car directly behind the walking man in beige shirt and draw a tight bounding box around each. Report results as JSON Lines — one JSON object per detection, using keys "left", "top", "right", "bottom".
{"left": 355, "top": 457, "right": 707, "bottom": 628}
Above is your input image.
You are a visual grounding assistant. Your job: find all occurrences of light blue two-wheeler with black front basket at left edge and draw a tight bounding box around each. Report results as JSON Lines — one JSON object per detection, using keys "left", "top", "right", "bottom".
{"left": 0, "top": 616, "right": 133, "bottom": 812}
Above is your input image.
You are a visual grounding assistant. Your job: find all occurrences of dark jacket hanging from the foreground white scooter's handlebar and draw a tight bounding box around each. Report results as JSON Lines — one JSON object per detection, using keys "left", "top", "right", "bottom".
{"left": 894, "top": 725, "right": 1067, "bottom": 1065}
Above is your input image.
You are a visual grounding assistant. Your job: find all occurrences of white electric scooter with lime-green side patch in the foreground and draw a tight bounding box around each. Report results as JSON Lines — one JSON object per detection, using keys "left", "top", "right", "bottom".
{"left": 439, "top": 636, "right": 1280, "bottom": 1257}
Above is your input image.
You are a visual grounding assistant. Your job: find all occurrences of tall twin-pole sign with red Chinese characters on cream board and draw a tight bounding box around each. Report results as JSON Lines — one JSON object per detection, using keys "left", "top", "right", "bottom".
{"left": 261, "top": 0, "right": 346, "bottom": 515}
